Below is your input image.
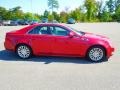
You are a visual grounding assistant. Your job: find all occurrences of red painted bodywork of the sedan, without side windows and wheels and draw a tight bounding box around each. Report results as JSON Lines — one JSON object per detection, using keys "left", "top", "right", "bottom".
{"left": 4, "top": 24, "right": 114, "bottom": 58}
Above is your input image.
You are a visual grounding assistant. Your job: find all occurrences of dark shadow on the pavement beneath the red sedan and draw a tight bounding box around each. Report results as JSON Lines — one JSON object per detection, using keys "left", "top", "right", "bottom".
{"left": 0, "top": 50, "right": 106, "bottom": 64}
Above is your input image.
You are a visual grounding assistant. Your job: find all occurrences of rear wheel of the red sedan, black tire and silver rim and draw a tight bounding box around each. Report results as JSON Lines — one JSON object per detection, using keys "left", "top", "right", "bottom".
{"left": 16, "top": 44, "right": 32, "bottom": 59}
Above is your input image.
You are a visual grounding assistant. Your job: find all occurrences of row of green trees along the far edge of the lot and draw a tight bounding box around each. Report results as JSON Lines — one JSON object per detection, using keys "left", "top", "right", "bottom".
{"left": 0, "top": 0, "right": 120, "bottom": 23}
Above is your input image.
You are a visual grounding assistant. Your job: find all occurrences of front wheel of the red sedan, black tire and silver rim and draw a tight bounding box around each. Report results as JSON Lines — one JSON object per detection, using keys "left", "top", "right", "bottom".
{"left": 87, "top": 46, "right": 106, "bottom": 62}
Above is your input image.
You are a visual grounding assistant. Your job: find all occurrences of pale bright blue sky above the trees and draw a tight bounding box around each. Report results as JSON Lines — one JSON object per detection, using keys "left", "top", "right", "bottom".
{"left": 0, "top": 0, "right": 105, "bottom": 14}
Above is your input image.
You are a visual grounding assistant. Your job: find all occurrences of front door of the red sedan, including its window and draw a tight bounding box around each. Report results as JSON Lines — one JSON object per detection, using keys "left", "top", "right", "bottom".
{"left": 51, "top": 26, "right": 84, "bottom": 56}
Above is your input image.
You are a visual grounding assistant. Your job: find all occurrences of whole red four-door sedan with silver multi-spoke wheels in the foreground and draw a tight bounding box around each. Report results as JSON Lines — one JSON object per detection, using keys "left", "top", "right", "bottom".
{"left": 4, "top": 24, "right": 114, "bottom": 62}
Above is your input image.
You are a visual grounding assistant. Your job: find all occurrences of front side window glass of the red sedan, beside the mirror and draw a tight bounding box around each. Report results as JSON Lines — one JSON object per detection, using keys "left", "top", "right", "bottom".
{"left": 50, "top": 26, "right": 69, "bottom": 36}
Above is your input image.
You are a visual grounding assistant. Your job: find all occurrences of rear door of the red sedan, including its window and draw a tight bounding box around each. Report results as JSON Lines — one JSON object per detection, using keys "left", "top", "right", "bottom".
{"left": 29, "top": 26, "right": 54, "bottom": 54}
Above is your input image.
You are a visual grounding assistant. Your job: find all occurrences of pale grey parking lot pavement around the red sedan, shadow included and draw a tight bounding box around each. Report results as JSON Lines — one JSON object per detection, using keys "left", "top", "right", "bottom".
{"left": 0, "top": 23, "right": 120, "bottom": 90}
